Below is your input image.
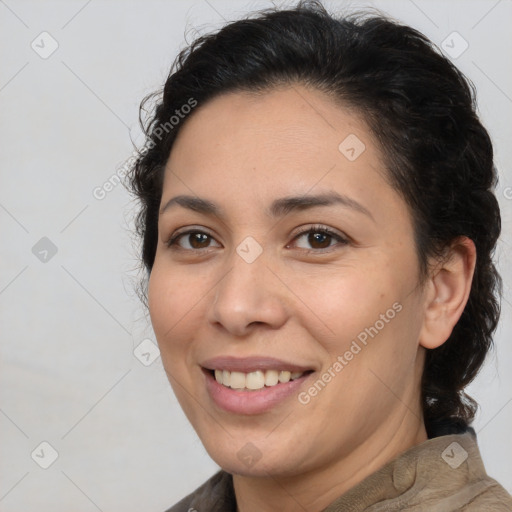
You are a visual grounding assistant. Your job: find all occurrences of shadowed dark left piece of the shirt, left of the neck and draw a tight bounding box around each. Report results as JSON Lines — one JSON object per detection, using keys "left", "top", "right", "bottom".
{"left": 165, "top": 471, "right": 236, "bottom": 512}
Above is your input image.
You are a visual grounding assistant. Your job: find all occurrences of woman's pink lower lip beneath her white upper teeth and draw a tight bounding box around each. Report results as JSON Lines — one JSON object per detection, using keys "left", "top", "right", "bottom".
{"left": 203, "top": 370, "right": 312, "bottom": 414}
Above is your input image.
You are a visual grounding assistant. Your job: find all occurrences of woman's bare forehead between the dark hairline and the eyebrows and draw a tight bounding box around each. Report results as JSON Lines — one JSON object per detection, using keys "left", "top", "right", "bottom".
{"left": 162, "top": 85, "right": 404, "bottom": 222}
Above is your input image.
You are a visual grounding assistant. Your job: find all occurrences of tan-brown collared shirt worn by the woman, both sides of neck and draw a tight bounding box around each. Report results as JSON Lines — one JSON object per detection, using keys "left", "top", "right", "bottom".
{"left": 166, "top": 432, "right": 512, "bottom": 512}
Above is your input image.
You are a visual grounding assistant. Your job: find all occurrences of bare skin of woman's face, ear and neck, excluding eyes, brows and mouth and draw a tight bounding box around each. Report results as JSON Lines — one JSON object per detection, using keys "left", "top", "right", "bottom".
{"left": 148, "top": 84, "right": 474, "bottom": 512}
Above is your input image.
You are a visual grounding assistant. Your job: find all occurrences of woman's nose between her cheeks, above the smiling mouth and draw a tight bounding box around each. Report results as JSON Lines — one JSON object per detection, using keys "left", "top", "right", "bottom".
{"left": 208, "top": 247, "right": 289, "bottom": 337}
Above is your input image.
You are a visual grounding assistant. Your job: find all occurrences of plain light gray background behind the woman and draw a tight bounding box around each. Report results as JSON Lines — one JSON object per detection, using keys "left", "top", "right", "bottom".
{"left": 0, "top": 0, "right": 512, "bottom": 512}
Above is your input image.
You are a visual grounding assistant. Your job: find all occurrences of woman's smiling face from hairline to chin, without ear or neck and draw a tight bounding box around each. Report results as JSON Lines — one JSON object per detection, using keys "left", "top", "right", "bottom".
{"left": 149, "top": 85, "right": 425, "bottom": 475}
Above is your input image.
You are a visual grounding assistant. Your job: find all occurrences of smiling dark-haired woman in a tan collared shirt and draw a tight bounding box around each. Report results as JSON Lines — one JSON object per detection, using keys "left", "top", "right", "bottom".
{"left": 127, "top": 2, "right": 512, "bottom": 512}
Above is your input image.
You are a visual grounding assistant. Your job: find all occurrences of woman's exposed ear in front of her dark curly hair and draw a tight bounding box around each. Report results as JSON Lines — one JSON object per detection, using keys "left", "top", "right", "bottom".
{"left": 419, "top": 237, "right": 476, "bottom": 349}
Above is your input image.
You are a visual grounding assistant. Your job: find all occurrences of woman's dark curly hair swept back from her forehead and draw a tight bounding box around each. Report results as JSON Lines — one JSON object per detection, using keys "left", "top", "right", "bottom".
{"left": 128, "top": 1, "right": 501, "bottom": 437}
